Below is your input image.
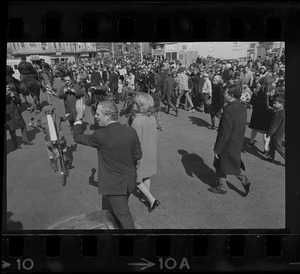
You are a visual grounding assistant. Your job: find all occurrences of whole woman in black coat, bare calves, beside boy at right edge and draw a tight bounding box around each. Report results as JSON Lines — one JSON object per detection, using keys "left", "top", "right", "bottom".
{"left": 248, "top": 84, "right": 272, "bottom": 154}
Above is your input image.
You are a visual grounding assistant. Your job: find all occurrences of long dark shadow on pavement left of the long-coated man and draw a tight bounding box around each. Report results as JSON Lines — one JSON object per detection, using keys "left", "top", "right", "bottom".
{"left": 177, "top": 149, "right": 217, "bottom": 187}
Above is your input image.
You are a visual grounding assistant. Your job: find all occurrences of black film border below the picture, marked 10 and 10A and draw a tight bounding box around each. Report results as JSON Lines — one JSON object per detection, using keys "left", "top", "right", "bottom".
{"left": 2, "top": 235, "right": 300, "bottom": 273}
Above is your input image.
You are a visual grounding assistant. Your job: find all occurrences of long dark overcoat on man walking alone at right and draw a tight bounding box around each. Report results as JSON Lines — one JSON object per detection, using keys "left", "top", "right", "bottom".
{"left": 214, "top": 100, "right": 247, "bottom": 175}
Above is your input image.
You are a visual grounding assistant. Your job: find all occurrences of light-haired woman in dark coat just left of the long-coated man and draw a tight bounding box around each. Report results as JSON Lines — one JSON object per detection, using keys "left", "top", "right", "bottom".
{"left": 209, "top": 75, "right": 224, "bottom": 130}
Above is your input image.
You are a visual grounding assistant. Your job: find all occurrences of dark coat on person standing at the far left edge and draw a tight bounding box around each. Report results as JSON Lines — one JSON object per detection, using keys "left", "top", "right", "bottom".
{"left": 5, "top": 91, "right": 26, "bottom": 130}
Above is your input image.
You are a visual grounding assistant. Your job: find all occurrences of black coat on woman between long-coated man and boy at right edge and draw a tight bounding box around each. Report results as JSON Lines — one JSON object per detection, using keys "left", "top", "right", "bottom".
{"left": 249, "top": 91, "right": 272, "bottom": 131}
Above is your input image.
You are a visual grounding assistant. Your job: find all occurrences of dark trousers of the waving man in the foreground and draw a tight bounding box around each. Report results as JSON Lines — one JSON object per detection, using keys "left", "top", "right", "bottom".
{"left": 107, "top": 195, "right": 134, "bottom": 229}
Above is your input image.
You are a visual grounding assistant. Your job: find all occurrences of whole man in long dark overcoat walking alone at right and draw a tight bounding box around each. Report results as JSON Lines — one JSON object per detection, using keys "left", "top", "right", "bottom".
{"left": 209, "top": 84, "right": 251, "bottom": 196}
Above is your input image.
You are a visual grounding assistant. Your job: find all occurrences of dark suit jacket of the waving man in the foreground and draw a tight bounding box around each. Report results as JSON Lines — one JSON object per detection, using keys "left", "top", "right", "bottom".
{"left": 73, "top": 122, "right": 142, "bottom": 195}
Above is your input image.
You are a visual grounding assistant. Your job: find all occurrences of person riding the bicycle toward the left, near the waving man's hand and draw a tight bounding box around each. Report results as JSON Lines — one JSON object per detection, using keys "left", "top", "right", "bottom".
{"left": 29, "top": 105, "right": 70, "bottom": 172}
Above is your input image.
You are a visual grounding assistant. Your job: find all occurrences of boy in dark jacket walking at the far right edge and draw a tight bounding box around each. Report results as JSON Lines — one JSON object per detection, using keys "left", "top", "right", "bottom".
{"left": 266, "top": 94, "right": 285, "bottom": 163}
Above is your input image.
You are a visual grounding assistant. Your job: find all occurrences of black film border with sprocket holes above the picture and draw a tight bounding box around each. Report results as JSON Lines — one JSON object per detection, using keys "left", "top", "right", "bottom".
{"left": 8, "top": 2, "right": 297, "bottom": 42}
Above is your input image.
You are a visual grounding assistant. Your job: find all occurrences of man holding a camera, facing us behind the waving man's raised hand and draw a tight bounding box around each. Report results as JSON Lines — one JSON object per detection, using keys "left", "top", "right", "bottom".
{"left": 58, "top": 75, "right": 84, "bottom": 133}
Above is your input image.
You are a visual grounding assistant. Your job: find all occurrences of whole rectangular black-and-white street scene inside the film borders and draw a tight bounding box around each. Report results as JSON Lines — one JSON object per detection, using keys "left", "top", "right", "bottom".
{"left": 4, "top": 41, "right": 286, "bottom": 229}
